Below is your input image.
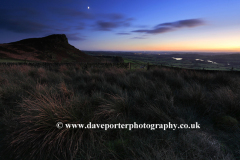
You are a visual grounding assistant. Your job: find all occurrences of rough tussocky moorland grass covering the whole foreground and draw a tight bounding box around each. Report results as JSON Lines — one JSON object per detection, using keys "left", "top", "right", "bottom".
{"left": 0, "top": 66, "right": 240, "bottom": 160}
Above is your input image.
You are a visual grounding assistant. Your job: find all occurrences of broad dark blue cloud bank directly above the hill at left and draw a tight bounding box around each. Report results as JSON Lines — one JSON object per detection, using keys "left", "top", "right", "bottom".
{"left": 0, "top": 8, "right": 85, "bottom": 34}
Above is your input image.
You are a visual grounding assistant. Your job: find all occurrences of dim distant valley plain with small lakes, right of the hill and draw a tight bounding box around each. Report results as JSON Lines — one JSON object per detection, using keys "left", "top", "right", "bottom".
{"left": 85, "top": 51, "right": 240, "bottom": 71}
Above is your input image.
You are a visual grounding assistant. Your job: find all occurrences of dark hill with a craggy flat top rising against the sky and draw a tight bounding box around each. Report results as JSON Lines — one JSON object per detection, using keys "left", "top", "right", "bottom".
{"left": 0, "top": 34, "right": 99, "bottom": 62}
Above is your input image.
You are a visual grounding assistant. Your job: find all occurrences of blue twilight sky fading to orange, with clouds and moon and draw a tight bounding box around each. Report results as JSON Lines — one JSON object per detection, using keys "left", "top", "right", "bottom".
{"left": 0, "top": 0, "right": 240, "bottom": 52}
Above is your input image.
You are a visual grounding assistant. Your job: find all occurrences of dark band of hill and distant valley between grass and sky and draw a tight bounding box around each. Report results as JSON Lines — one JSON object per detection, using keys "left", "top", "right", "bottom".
{"left": 0, "top": 34, "right": 240, "bottom": 71}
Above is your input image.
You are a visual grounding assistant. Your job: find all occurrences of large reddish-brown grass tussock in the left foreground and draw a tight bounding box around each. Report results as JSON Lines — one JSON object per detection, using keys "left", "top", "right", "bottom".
{"left": 3, "top": 93, "right": 96, "bottom": 159}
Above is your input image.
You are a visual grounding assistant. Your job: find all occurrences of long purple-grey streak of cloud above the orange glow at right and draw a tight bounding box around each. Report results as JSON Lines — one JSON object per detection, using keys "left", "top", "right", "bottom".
{"left": 132, "top": 19, "right": 204, "bottom": 34}
